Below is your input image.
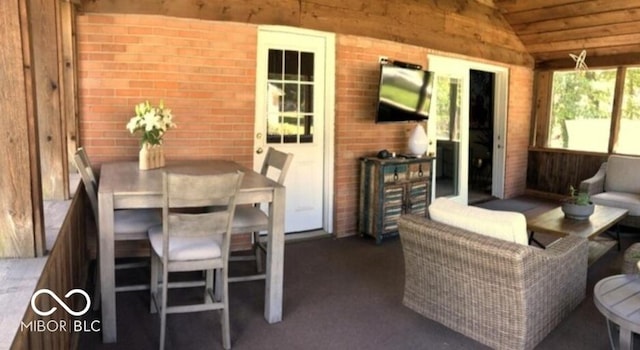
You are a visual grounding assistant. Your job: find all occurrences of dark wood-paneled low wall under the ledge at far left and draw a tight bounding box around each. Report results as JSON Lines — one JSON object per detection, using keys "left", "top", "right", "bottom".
{"left": 11, "top": 189, "right": 92, "bottom": 350}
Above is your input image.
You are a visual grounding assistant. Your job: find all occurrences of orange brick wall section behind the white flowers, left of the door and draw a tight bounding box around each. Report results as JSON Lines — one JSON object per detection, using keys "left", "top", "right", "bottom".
{"left": 77, "top": 15, "right": 257, "bottom": 166}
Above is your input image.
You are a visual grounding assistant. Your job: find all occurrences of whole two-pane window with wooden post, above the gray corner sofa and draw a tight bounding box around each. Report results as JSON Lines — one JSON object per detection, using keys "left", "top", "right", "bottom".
{"left": 547, "top": 67, "right": 640, "bottom": 155}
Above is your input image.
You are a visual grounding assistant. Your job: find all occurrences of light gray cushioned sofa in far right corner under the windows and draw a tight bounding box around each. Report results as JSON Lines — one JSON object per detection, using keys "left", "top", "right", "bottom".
{"left": 580, "top": 155, "right": 640, "bottom": 228}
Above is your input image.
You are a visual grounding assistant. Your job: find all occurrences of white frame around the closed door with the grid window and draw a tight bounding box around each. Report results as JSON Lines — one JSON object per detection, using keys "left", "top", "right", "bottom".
{"left": 254, "top": 25, "right": 336, "bottom": 234}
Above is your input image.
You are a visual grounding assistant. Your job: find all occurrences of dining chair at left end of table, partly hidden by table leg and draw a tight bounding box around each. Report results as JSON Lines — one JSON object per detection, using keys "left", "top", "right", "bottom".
{"left": 73, "top": 147, "right": 162, "bottom": 309}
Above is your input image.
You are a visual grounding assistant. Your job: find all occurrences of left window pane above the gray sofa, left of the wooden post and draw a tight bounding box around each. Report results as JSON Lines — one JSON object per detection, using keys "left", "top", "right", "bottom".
{"left": 547, "top": 69, "right": 616, "bottom": 152}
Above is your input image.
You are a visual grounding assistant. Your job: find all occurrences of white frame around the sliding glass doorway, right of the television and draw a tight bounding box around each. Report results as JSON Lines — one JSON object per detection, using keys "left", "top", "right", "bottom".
{"left": 427, "top": 54, "right": 509, "bottom": 204}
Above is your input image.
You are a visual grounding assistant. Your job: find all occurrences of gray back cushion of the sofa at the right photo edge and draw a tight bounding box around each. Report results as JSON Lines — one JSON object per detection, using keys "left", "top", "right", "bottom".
{"left": 604, "top": 156, "right": 640, "bottom": 194}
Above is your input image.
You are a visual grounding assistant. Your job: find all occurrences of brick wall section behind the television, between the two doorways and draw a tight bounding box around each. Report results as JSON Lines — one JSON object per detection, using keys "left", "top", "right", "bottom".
{"left": 334, "top": 35, "right": 427, "bottom": 236}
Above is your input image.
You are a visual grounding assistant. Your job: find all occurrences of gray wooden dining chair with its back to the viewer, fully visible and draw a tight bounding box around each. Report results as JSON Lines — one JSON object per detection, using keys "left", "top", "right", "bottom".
{"left": 149, "top": 171, "right": 244, "bottom": 350}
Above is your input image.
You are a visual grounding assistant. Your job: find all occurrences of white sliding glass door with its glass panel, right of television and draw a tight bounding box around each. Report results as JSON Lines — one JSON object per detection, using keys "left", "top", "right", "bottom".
{"left": 427, "top": 55, "right": 508, "bottom": 204}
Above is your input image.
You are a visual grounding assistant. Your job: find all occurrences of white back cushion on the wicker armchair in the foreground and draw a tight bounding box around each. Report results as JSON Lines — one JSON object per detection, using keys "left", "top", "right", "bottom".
{"left": 429, "top": 198, "right": 529, "bottom": 245}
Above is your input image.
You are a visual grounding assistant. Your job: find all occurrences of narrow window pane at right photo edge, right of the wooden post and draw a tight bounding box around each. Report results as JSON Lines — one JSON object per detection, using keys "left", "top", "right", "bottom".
{"left": 614, "top": 68, "right": 640, "bottom": 155}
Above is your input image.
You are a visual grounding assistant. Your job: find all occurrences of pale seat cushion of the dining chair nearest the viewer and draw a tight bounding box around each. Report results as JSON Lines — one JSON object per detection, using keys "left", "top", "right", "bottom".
{"left": 149, "top": 225, "right": 222, "bottom": 261}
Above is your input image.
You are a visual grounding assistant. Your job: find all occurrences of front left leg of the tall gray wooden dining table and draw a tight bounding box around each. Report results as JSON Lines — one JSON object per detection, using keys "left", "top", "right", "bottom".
{"left": 98, "top": 194, "right": 117, "bottom": 343}
